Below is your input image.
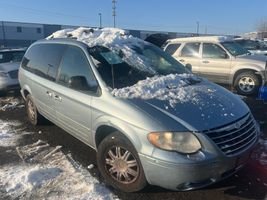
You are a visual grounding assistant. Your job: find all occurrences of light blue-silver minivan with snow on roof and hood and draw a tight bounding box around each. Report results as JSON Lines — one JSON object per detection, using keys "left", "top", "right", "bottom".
{"left": 19, "top": 28, "right": 259, "bottom": 192}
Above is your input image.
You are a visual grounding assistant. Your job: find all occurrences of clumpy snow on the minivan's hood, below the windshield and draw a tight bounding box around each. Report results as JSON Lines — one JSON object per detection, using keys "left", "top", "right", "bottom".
{"left": 112, "top": 74, "right": 215, "bottom": 107}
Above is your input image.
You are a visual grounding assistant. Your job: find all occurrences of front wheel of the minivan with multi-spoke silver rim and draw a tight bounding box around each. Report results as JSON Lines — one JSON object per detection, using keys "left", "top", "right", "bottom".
{"left": 97, "top": 131, "right": 147, "bottom": 192}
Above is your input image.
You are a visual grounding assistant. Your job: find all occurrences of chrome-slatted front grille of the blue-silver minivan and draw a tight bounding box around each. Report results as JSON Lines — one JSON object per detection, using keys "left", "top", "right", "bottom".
{"left": 203, "top": 114, "right": 257, "bottom": 156}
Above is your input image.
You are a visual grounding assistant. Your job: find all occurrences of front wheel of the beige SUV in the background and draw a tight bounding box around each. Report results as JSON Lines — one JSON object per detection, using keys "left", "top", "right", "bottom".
{"left": 234, "top": 71, "right": 260, "bottom": 95}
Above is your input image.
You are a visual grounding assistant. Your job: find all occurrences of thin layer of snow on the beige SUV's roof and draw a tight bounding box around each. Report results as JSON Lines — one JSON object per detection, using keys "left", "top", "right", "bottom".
{"left": 167, "top": 36, "right": 234, "bottom": 43}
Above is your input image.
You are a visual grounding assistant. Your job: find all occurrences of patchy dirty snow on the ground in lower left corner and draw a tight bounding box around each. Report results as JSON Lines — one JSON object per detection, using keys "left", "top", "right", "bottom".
{"left": 0, "top": 121, "right": 116, "bottom": 200}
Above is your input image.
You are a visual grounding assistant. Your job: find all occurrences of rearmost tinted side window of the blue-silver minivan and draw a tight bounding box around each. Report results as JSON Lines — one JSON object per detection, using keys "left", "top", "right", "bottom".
{"left": 22, "top": 44, "right": 66, "bottom": 81}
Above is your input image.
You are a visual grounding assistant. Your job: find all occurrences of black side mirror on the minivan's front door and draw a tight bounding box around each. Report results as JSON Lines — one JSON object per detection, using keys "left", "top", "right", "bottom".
{"left": 69, "top": 76, "right": 98, "bottom": 92}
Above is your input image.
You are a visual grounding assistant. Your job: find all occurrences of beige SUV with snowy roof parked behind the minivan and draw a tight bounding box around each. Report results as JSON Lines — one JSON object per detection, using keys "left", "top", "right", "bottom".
{"left": 164, "top": 36, "right": 267, "bottom": 95}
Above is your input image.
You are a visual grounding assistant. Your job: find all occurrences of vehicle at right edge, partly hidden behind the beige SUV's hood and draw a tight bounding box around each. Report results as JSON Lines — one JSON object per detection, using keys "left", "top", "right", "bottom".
{"left": 235, "top": 38, "right": 267, "bottom": 56}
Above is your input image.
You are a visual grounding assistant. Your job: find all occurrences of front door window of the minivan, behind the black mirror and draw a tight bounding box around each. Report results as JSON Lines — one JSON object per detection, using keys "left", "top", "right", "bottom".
{"left": 58, "top": 46, "right": 98, "bottom": 92}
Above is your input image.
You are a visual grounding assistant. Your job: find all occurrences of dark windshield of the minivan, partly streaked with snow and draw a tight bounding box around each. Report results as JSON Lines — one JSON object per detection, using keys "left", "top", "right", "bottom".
{"left": 88, "top": 44, "right": 190, "bottom": 88}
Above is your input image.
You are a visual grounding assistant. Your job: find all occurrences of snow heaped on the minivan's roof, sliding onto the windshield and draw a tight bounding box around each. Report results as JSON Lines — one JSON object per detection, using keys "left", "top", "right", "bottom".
{"left": 46, "top": 27, "right": 155, "bottom": 74}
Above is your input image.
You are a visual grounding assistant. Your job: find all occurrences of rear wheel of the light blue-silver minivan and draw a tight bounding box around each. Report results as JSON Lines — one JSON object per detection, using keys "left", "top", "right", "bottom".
{"left": 26, "top": 94, "right": 43, "bottom": 125}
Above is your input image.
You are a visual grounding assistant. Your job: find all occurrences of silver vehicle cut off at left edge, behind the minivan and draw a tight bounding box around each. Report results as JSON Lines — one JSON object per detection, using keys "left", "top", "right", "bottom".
{"left": 0, "top": 49, "right": 26, "bottom": 93}
